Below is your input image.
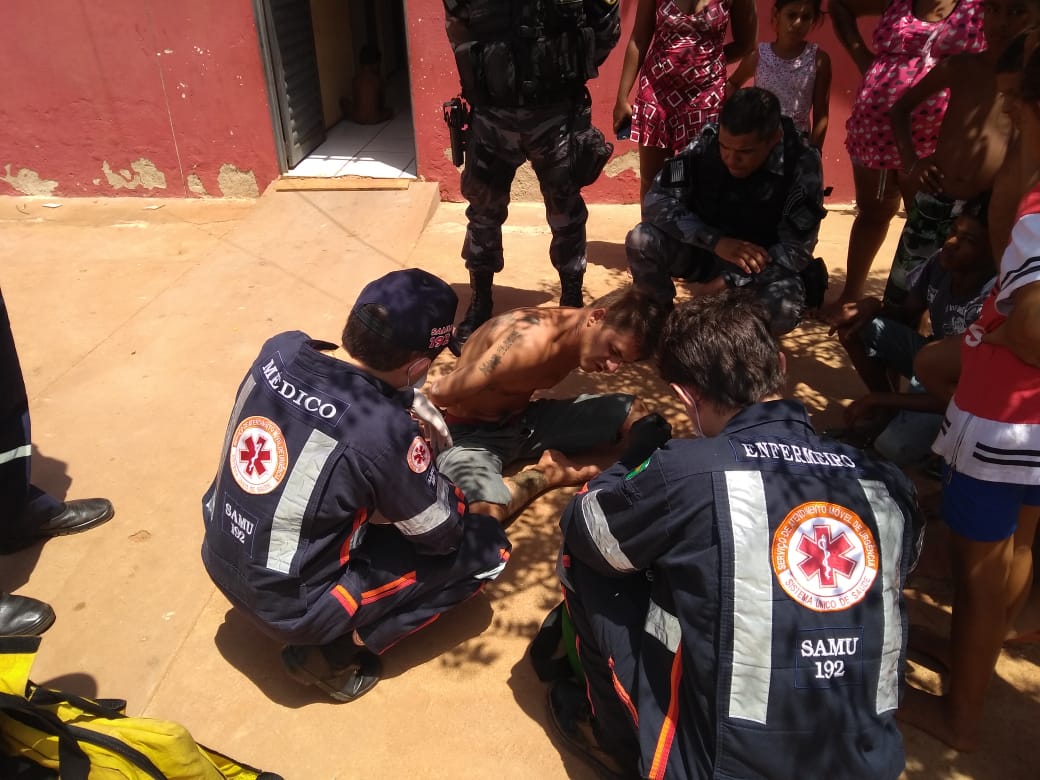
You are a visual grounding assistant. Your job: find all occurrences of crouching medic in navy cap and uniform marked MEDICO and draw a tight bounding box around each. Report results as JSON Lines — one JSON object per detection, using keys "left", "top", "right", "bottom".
{"left": 202, "top": 268, "right": 510, "bottom": 701}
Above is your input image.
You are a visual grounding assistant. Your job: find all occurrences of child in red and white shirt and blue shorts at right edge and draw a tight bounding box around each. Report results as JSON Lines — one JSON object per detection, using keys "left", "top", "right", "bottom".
{"left": 900, "top": 45, "right": 1040, "bottom": 750}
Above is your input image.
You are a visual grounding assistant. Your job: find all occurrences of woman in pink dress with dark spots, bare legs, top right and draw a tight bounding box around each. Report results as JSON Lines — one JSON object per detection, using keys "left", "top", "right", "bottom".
{"left": 828, "top": 0, "right": 986, "bottom": 315}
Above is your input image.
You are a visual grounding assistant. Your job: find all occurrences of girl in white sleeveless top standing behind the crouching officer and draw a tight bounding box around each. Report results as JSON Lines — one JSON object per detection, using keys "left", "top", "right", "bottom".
{"left": 727, "top": 0, "right": 831, "bottom": 149}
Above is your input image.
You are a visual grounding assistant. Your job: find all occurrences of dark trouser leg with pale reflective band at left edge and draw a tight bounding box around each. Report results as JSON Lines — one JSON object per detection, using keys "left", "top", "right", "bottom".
{"left": 0, "top": 291, "right": 60, "bottom": 538}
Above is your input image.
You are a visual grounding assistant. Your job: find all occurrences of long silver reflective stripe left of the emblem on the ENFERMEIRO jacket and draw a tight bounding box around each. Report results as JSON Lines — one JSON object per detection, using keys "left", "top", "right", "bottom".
{"left": 725, "top": 471, "right": 773, "bottom": 724}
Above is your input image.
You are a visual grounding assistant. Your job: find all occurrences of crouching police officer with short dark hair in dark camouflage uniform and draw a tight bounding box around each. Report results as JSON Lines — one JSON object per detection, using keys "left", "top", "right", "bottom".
{"left": 625, "top": 87, "right": 826, "bottom": 335}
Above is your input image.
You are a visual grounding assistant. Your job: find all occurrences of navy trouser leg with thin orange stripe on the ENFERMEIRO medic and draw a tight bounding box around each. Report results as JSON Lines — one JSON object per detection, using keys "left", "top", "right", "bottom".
{"left": 564, "top": 558, "right": 650, "bottom": 770}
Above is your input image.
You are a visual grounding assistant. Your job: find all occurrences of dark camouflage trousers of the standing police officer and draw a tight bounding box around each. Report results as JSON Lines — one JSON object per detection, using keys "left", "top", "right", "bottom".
{"left": 462, "top": 101, "right": 589, "bottom": 277}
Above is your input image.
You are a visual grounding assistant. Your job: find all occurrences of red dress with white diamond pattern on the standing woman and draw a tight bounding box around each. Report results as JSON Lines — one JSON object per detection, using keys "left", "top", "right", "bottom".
{"left": 631, "top": 0, "right": 729, "bottom": 151}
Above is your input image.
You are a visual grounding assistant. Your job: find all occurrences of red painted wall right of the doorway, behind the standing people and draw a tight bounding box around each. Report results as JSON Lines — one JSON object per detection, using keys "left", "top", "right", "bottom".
{"left": 408, "top": 0, "right": 873, "bottom": 204}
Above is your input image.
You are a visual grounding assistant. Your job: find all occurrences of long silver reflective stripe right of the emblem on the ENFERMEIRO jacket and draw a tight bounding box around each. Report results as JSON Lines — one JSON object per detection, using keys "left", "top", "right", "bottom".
{"left": 859, "top": 479, "right": 904, "bottom": 714}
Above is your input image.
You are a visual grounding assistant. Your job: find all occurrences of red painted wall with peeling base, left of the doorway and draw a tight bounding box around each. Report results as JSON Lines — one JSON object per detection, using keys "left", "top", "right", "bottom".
{"left": 0, "top": 0, "right": 278, "bottom": 197}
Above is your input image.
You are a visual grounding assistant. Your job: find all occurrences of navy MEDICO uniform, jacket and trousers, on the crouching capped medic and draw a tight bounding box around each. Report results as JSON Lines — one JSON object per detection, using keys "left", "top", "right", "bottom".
{"left": 202, "top": 332, "right": 510, "bottom": 652}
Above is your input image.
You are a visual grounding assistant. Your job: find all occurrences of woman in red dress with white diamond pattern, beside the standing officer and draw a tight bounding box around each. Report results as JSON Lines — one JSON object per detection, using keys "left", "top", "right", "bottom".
{"left": 614, "top": 0, "right": 758, "bottom": 203}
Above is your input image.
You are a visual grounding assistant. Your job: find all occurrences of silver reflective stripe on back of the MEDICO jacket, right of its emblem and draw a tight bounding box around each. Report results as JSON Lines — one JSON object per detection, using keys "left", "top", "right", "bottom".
{"left": 264, "top": 430, "right": 336, "bottom": 574}
